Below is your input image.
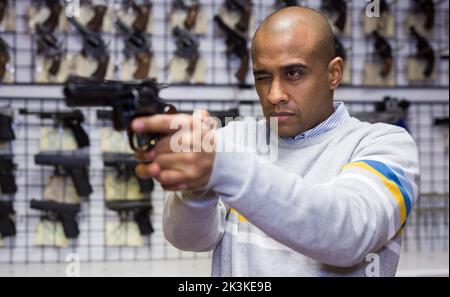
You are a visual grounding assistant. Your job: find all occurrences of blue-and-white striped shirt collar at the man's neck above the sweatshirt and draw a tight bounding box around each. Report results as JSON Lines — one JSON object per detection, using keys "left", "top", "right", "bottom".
{"left": 291, "top": 102, "right": 350, "bottom": 140}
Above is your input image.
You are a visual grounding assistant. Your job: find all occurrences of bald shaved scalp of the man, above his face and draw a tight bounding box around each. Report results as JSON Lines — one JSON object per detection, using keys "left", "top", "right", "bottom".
{"left": 252, "top": 6, "right": 335, "bottom": 64}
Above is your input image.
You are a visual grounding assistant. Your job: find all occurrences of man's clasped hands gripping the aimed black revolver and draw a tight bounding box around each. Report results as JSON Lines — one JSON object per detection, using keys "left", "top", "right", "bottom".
{"left": 132, "top": 111, "right": 216, "bottom": 191}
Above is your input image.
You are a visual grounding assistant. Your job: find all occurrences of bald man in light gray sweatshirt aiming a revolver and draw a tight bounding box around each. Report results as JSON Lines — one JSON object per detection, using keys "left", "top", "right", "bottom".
{"left": 133, "top": 7, "right": 419, "bottom": 276}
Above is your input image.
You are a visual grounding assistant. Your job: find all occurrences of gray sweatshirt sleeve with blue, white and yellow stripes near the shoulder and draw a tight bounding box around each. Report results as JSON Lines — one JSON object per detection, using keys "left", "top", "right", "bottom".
{"left": 208, "top": 124, "right": 419, "bottom": 267}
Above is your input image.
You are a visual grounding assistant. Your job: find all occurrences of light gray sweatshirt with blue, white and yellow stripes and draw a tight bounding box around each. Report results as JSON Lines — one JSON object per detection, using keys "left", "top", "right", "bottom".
{"left": 163, "top": 103, "right": 419, "bottom": 276}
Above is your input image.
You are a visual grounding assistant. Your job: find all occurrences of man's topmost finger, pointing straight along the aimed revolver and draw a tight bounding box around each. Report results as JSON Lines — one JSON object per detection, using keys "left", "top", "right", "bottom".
{"left": 131, "top": 114, "right": 192, "bottom": 134}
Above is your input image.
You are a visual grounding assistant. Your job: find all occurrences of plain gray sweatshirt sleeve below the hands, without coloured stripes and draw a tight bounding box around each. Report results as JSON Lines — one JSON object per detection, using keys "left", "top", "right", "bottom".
{"left": 163, "top": 192, "right": 227, "bottom": 252}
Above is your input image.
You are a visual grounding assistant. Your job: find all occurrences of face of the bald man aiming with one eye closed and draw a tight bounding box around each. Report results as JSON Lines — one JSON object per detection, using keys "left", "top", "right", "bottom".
{"left": 252, "top": 30, "right": 332, "bottom": 137}
